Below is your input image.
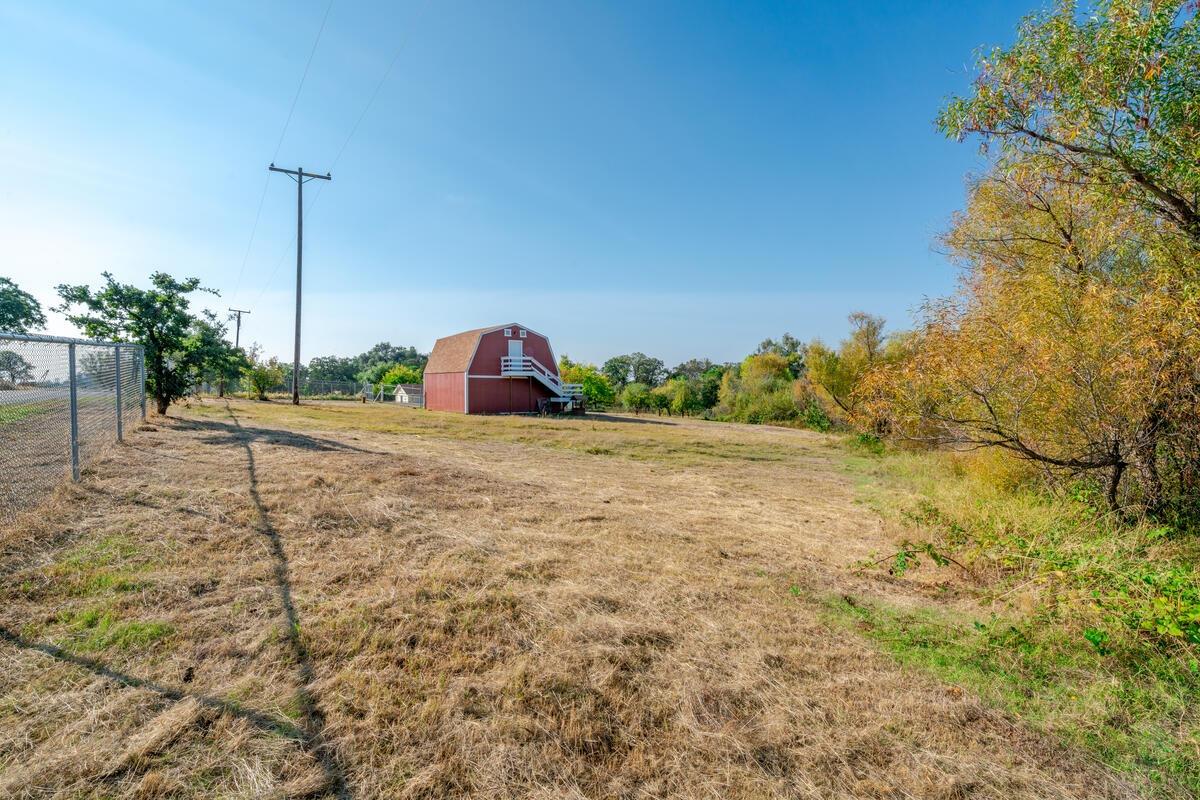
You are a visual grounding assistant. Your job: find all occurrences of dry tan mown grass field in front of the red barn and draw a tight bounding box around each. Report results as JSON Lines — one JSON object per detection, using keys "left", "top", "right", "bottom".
{"left": 0, "top": 401, "right": 1140, "bottom": 800}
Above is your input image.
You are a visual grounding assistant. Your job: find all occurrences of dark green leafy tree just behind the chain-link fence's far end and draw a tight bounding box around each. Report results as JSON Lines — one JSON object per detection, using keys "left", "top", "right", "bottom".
{"left": 58, "top": 272, "right": 216, "bottom": 414}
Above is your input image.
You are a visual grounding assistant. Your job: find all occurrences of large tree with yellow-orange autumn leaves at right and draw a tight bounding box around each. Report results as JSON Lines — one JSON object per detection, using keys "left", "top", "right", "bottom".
{"left": 858, "top": 172, "right": 1200, "bottom": 510}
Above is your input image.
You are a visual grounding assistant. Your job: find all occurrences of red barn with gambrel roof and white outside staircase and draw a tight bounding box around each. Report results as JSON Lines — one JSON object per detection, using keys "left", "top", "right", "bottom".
{"left": 425, "top": 323, "right": 583, "bottom": 414}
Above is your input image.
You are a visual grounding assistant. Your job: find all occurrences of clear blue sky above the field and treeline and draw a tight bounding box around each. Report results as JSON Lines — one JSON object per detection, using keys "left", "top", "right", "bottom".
{"left": 0, "top": 0, "right": 1042, "bottom": 362}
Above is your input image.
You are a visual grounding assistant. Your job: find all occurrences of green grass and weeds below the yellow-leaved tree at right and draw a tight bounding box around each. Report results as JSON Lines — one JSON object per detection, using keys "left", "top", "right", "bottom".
{"left": 832, "top": 441, "right": 1200, "bottom": 796}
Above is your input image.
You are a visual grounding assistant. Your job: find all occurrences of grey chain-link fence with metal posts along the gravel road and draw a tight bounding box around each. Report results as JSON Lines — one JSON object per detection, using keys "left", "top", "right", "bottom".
{"left": 0, "top": 332, "right": 145, "bottom": 518}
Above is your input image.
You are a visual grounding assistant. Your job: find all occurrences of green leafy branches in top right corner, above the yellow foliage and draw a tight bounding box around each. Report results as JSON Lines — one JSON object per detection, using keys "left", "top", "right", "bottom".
{"left": 937, "top": 0, "right": 1200, "bottom": 245}
